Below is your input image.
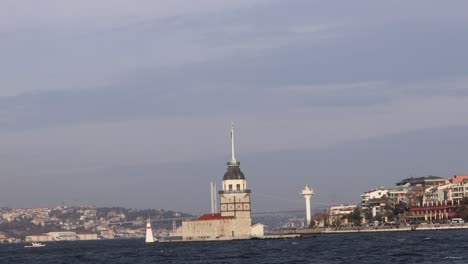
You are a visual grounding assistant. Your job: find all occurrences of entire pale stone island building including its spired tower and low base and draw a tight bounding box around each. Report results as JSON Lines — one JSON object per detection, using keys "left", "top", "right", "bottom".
{"left": 181, "top": 122, "right": 264, "bottom": 240}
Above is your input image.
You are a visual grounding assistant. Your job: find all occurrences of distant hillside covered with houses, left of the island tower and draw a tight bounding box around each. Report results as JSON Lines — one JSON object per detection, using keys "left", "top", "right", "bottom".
{"left": 0, "top": 206, "right": 191, "bottom": 238}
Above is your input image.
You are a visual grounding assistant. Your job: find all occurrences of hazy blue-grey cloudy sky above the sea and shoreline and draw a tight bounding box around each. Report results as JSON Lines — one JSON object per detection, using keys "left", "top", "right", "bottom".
{"left": 0, "top": 0, "right": 468, "bottom": 213}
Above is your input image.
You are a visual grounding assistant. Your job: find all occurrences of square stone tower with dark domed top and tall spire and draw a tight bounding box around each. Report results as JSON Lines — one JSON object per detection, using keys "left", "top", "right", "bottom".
{"left": 219, "top": 123, "right": 251, "bottom": 220}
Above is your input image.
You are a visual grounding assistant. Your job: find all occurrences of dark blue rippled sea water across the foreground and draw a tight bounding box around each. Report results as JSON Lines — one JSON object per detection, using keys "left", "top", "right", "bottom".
{"left": 0, "top": 230, "right": 468, "bottom": 264}
